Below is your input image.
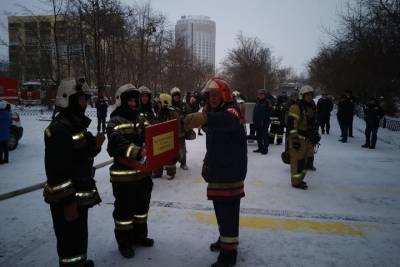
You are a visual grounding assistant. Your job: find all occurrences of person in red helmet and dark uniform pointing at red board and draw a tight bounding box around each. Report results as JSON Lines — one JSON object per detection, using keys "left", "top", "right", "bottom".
{"left": 185, "top": 78, "right": 247, "bottom": 267}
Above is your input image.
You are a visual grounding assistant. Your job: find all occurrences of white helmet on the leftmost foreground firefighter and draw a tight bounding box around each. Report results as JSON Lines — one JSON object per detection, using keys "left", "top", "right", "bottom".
{"left": 56, "top": 79, "right": 91, "bottom": 108}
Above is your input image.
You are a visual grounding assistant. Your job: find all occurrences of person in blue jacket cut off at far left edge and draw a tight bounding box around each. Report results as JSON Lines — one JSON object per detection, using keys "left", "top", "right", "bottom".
{"left": 0, "top": 101, "right": 11, "bottom": 164}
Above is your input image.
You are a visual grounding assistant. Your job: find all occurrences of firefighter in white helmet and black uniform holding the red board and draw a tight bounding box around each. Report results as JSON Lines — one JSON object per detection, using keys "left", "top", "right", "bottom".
{"left": 107, "top": 84, "right": 154, "bottom": 258}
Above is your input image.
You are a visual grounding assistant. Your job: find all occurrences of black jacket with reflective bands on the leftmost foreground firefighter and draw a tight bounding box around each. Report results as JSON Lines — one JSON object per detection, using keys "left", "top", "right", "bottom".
{"left": 43, "top": 112, "right": 101, "bottom": 207}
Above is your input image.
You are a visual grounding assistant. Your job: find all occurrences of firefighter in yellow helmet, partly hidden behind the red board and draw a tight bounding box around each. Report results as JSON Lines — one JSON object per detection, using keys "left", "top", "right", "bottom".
{"left": 153, "top": 94, "right": 178, "bottom": 180}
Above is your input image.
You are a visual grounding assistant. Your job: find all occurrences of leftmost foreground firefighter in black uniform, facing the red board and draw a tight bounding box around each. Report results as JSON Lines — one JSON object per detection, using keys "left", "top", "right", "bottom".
{"left": 43, "top": 79, "right": 105, "bottom": 267}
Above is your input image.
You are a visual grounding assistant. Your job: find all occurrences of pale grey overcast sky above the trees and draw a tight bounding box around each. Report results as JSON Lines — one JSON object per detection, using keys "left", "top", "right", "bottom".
{"left": 0, "top": 0, "right": 348, "bottom": 73}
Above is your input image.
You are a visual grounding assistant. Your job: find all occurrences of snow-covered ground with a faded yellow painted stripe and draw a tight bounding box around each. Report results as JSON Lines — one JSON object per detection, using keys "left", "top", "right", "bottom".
{"left": 0, "top": 108, "right": 400, "bottom": 267}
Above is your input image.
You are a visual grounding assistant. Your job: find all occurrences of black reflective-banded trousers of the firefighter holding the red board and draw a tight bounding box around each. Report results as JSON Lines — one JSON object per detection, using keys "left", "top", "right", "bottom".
{"left": 112, "top": 176, "right": 153, "bottom": 249}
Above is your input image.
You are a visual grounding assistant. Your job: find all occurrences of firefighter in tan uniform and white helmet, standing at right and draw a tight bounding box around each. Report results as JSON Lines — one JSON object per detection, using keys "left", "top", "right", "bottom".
{"left": 287, "top": 85, "right": 320, "bottom": 189}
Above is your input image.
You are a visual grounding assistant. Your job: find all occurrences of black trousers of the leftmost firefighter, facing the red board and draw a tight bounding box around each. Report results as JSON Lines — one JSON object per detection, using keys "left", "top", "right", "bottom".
{"left": 50, "top": 204, "right": 88, "bottom": 267}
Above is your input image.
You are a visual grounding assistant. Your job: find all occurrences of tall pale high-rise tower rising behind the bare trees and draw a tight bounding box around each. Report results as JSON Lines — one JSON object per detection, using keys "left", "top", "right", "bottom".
{"left": 175, "top": 16, "right": 215, "bottom": 69}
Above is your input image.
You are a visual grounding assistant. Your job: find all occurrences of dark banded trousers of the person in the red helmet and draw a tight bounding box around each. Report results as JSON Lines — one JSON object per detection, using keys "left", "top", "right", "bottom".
{"left": 213, "top": 198, "right": 240, "bottom": 263}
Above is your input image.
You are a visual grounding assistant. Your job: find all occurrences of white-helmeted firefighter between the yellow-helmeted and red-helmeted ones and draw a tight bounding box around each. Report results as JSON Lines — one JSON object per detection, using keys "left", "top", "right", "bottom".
{"left": 170, "top": 87, "right": 189, "bottom": 170}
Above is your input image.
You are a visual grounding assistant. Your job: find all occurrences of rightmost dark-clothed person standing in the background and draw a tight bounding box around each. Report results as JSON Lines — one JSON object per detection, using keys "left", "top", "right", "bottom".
{"left": 362, "top": 98, "right": 385, "bottom": 149}
